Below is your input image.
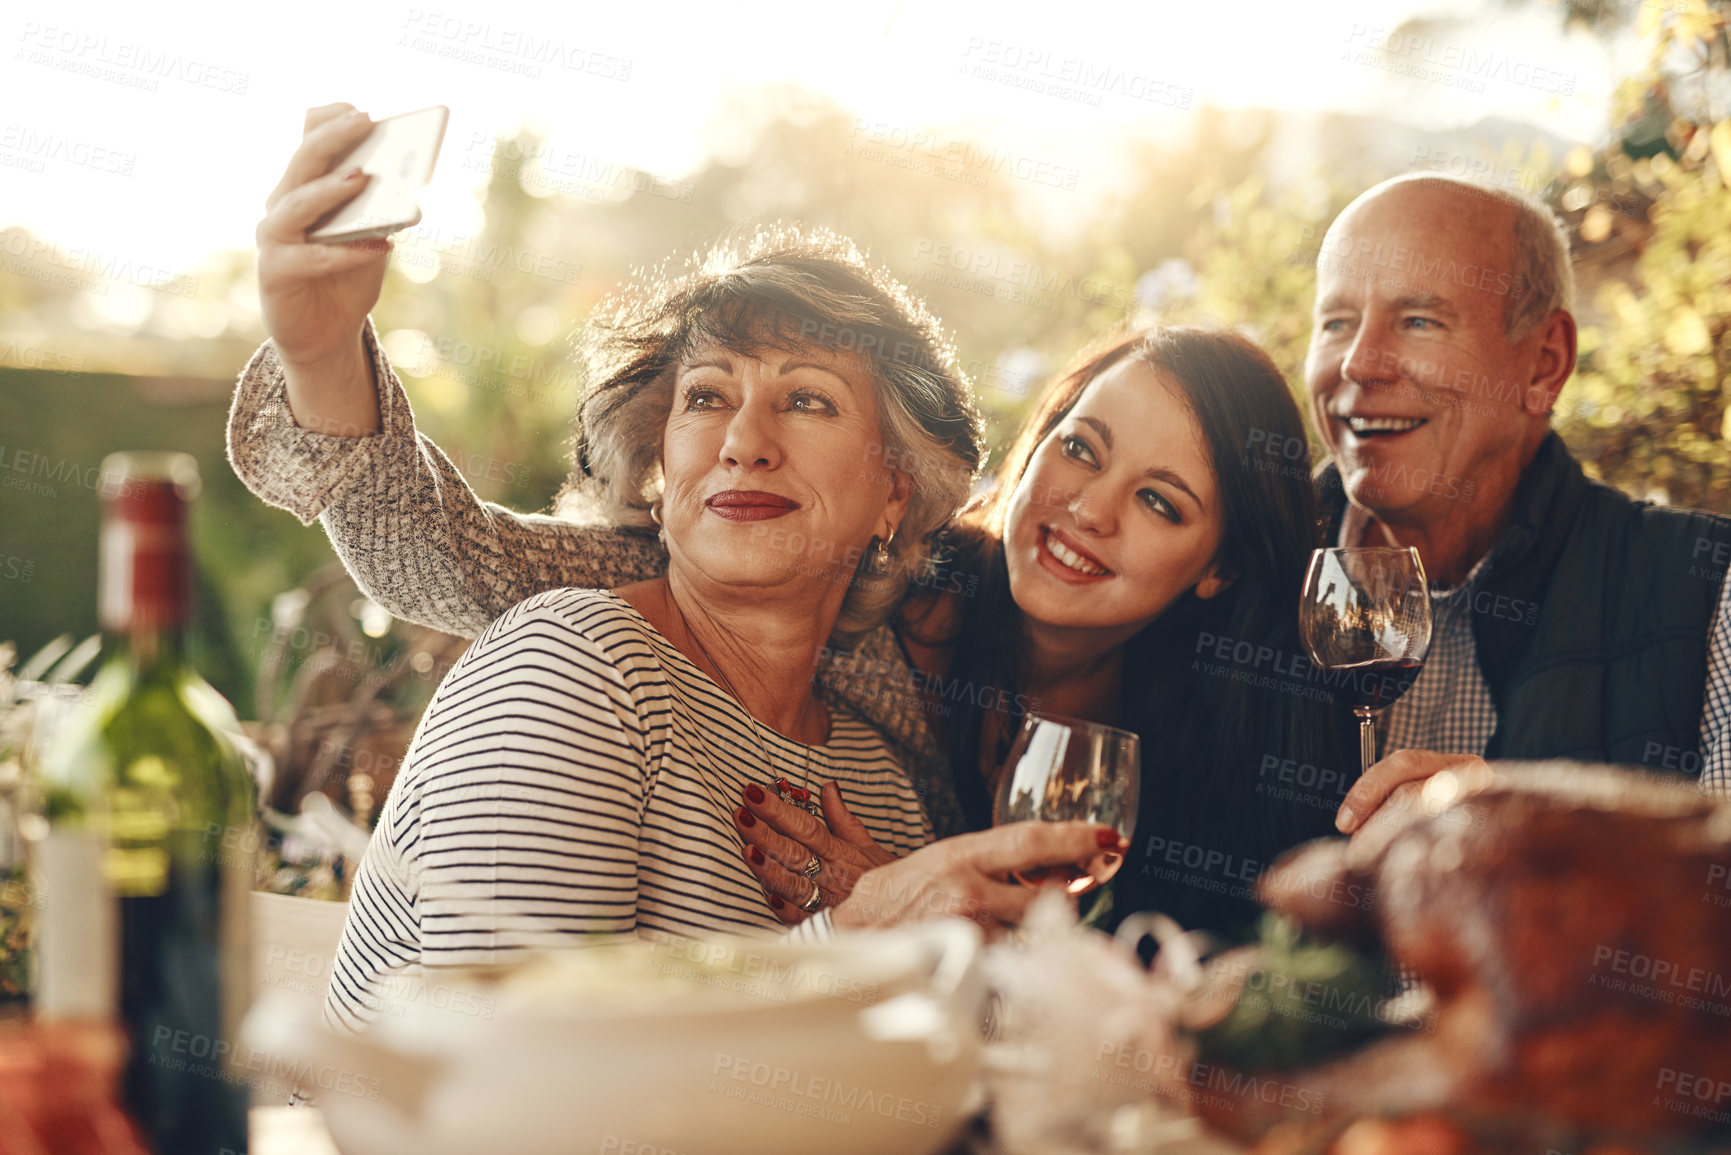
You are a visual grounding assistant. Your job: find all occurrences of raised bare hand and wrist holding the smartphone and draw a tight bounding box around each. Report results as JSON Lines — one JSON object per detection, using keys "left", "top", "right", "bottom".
{"left": 256, "top": 104, "right": 391, "bottom": 436}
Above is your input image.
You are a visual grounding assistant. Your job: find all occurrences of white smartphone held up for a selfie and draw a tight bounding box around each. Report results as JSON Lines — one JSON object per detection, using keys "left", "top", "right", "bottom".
{"left": 306, "top": 104, "right": 450, "bottom": 244}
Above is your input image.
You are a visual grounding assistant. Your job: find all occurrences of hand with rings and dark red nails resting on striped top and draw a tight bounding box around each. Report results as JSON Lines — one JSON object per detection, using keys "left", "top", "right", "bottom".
{"left": 734, "top": 783, "right": 895, "bottom": 926}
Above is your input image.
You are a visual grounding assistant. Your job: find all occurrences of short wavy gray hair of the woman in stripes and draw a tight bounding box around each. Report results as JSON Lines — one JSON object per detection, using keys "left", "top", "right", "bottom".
{"left": 556, "top": 225, "right": 983, "bottom": 646}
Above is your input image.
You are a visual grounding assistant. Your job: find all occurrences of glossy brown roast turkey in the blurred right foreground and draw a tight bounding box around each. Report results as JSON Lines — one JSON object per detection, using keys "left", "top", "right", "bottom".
{"left": 1203, "top": 764, "right": 1731, "bottom": 1155}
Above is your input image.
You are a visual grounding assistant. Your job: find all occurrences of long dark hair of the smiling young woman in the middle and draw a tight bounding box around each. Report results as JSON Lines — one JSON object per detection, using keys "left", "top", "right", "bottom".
{"left": 916, "top": 327, "right": 1340, "bottom": 928}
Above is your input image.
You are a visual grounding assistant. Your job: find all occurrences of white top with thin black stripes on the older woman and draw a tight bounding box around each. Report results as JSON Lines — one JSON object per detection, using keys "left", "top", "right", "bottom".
{"left": 325, "top": 589, "right": 931, "bottom": 1029}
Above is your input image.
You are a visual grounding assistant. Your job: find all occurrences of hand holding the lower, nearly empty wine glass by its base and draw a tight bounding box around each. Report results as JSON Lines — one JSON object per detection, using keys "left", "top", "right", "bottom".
{"left": 831, "top": 823, "right": 1130, "bottom": 933}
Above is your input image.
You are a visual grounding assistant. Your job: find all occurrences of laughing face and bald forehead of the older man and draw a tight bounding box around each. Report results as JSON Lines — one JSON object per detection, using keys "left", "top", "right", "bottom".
{"left": 1305, "top": 180, "right": 1549, "bottom": 525}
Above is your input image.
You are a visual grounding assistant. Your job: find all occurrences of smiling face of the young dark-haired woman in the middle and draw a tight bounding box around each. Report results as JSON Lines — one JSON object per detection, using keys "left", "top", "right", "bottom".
{"left": 1004, "top": 360, "right": 1226, "bottom": 637}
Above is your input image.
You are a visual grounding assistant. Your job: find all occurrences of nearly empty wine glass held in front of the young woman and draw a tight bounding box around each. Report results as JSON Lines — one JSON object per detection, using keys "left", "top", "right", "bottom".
{"left": 992, "top": 713, "right": 1142, "bottom": 895}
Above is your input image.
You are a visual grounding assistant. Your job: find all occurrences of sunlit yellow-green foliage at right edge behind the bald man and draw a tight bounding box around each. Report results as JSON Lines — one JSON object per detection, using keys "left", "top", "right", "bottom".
{"left": 1556, "top": 0, "right": 1731, "bottom": 511}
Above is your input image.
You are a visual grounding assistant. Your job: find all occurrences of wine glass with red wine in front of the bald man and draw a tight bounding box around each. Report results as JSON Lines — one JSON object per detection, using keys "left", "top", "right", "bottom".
{"left": 1298, "top": 545, "right": 1430, "bottom": 771}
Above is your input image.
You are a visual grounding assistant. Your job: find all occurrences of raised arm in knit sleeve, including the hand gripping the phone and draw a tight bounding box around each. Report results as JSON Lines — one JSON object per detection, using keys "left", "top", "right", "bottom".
{"left": 228, "top": 104, "right": 666, "bottom": 637}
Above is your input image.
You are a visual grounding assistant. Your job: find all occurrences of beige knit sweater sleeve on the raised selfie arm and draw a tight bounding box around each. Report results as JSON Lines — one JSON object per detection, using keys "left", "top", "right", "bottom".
{"left": 228, "top": 320, "right": 666, "bottom": 637}
